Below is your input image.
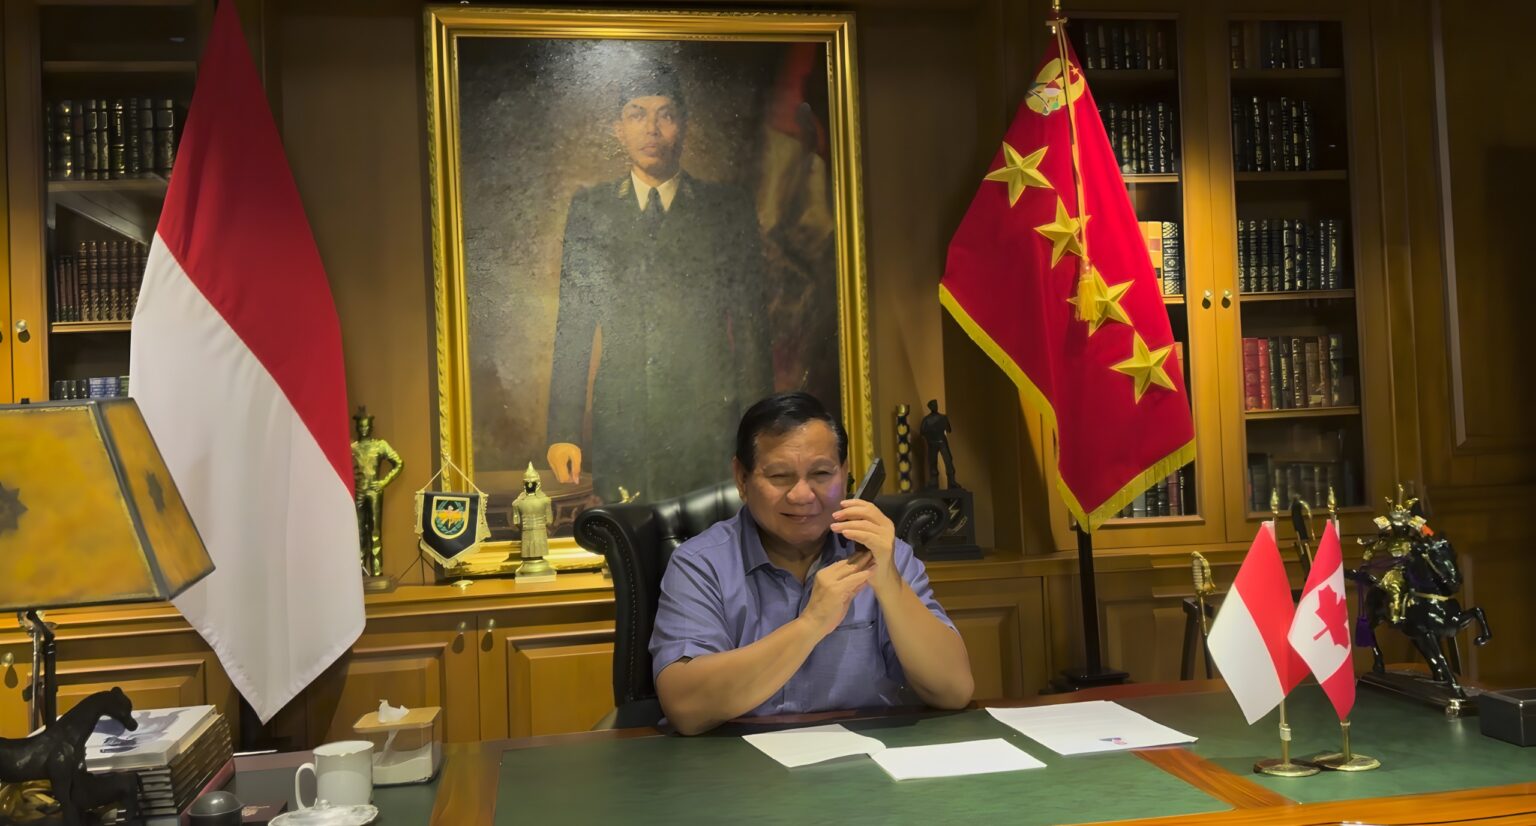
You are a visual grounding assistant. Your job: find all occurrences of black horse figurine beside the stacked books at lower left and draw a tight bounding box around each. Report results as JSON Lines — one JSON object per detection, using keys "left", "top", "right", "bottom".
{"left": 0, "top": 688, "right": 138, "bottom": 826}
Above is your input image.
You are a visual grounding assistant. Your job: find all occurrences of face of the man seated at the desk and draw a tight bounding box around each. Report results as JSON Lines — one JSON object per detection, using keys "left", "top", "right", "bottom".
{"left": 734, "top": 421, "right": 848, "bottom": 545}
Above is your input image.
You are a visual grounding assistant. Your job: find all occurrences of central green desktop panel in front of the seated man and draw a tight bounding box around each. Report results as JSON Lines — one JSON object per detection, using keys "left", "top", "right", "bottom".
{"left": 491, "top": 711, "right": 1230, "bottom": 826}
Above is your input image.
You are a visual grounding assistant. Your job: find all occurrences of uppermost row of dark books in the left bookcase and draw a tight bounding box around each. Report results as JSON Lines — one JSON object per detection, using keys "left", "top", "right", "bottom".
{"left": 43, "top": 97, "right": 180, "bottom": 181}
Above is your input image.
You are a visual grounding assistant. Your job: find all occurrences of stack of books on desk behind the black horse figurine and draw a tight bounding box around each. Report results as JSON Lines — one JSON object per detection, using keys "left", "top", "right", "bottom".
{"left": 84, "top": 706, "right": 235, "bottom": 826}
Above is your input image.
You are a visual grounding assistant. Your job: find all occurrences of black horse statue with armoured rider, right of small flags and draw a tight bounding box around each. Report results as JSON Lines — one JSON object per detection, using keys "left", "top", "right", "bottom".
{"left": 1349, "top": 488, "right": 1493, "bottom": 699}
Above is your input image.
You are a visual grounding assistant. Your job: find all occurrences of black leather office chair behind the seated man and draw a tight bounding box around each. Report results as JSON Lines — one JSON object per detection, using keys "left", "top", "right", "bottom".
{"left": 574, "top": 482, "right": 946, "bottom": 728}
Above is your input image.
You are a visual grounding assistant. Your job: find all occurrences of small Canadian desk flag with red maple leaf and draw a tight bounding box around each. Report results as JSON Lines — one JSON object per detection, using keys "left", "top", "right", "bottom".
{"left": 1290, "top": 520, "right": 1355, "bottom": 720}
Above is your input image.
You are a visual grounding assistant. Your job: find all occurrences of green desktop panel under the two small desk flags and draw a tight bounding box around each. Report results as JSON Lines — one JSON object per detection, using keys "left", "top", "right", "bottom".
{"left": 1120, "top": 685, "right": 1536, "bottom": 803}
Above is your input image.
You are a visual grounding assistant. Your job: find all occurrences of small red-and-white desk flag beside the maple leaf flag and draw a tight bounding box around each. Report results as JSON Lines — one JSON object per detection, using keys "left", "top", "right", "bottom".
{"left": 1206, "top": 522, "right": 1307, "bottom": 723}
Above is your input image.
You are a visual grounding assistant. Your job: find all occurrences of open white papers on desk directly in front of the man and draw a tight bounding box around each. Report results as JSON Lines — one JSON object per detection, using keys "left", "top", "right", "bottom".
{"left": 742, "top": 725, "right": 1044, "bottom": 780}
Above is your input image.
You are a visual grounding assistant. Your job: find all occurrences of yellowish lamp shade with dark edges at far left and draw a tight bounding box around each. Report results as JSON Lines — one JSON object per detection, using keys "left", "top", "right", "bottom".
{"left": 0, "top": 399, "right": 214, "bottom": 611}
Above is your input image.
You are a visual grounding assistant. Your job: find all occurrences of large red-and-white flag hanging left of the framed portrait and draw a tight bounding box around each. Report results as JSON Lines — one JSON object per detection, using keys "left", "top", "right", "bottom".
{"left": 129, "top": 2, "right": 362, "bottom": 722}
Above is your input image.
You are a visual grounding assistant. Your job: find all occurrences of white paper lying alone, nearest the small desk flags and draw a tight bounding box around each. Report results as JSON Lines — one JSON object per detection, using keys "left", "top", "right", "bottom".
{"left": 986, "top": 700, "right": 1195, "bottom": 754}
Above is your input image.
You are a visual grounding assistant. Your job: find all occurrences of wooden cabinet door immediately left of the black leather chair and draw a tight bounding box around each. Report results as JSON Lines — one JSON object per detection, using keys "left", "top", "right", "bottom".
{"left": 479, "top": 603, "right": 613, "bottom": 740}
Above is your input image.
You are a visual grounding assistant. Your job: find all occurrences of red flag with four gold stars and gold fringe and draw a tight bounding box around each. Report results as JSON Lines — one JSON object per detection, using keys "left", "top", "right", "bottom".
{"left": 938, "top": 38, "right": 1195, "bottom": 530}
